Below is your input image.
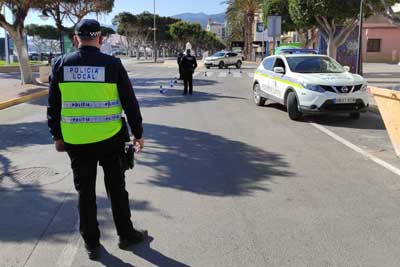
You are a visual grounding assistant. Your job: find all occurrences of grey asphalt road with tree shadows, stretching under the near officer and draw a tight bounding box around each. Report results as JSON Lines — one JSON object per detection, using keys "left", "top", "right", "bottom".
{"left": 0, "top": 63, "right": 400, "bottom": 267}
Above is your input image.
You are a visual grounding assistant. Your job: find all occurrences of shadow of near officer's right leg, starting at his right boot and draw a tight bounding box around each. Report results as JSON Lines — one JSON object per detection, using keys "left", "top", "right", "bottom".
{"left": 129, "top": 236, "right": 190, "bottom": 267}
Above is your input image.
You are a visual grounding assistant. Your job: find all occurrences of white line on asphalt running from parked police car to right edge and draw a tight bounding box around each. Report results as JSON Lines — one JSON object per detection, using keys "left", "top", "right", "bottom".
{"left": 310, "top": 123, "right": 400, "bottom": 176}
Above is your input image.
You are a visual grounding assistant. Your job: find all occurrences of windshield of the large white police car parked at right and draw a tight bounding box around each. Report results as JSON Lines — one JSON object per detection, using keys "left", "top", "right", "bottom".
{"left": 286, "top": 56, "right": 345, "bottom": 73}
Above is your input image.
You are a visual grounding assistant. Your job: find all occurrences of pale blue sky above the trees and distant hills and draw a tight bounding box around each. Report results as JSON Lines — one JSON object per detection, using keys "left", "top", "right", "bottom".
{"left": 26, "top": 0, "right": 226, "bottom": 24}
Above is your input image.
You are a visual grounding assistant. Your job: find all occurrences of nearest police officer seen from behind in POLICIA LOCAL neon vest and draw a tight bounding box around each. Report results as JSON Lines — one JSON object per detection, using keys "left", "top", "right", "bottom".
{"left": 47, "top": 19, "right": 147, "bottom": 259}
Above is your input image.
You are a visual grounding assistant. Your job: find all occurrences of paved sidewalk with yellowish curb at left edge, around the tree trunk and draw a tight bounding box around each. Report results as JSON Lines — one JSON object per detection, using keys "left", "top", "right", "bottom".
{"left": 0, "top": 73, "right": 48, "bottom": 110}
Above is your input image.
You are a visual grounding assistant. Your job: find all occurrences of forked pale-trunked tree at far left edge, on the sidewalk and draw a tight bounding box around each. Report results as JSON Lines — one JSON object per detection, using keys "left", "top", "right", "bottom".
{"left": 0, "top": 0, "right": 45, "bottom": 84}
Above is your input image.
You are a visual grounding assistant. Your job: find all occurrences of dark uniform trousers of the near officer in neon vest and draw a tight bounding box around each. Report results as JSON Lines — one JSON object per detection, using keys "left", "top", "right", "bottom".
{"left": 67, "top": 135, "right": 133, "bottom": 245}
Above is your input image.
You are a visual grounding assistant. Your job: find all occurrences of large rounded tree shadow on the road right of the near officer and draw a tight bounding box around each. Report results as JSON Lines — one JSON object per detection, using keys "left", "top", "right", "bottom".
{"left": 139, "top": 124, "right": 293, "bottom": 197}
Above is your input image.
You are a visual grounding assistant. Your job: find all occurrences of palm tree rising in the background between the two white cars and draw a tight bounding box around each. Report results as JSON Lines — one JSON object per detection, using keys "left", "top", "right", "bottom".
{"left": 224, "top": 0, "right": 263, "bottom": 59}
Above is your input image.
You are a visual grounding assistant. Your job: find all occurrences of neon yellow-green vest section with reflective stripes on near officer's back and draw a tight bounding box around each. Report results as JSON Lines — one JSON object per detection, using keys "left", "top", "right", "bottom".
{"left": 59, "top": 82, "right": 122, "bottom": 145}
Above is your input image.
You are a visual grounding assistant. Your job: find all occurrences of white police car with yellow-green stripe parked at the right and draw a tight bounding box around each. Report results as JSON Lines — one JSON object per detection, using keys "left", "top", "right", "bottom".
{"left": 253, "top": 54, "right": 369, "bottom": 120}
